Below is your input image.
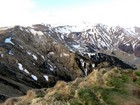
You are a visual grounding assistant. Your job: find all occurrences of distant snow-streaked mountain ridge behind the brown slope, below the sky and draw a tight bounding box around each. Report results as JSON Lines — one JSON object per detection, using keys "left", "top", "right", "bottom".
{"left": 46, "top": 24, "right": 140, "bottom": 56}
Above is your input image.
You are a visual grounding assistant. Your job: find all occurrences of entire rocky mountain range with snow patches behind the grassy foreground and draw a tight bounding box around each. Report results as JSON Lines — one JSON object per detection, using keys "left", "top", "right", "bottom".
{"left": 0, "top": 24, "right": 140, "bottom": 102}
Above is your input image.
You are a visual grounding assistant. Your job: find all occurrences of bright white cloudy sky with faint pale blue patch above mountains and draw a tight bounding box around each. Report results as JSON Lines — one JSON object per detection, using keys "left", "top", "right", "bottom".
{"left": 0, "top": 0, "right": 140, "bottom": 27}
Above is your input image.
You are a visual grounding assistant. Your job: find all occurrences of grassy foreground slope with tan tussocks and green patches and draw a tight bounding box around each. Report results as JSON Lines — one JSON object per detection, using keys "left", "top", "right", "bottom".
{"left": 2, "top": 68, "right": 140, "bottom": 105}
